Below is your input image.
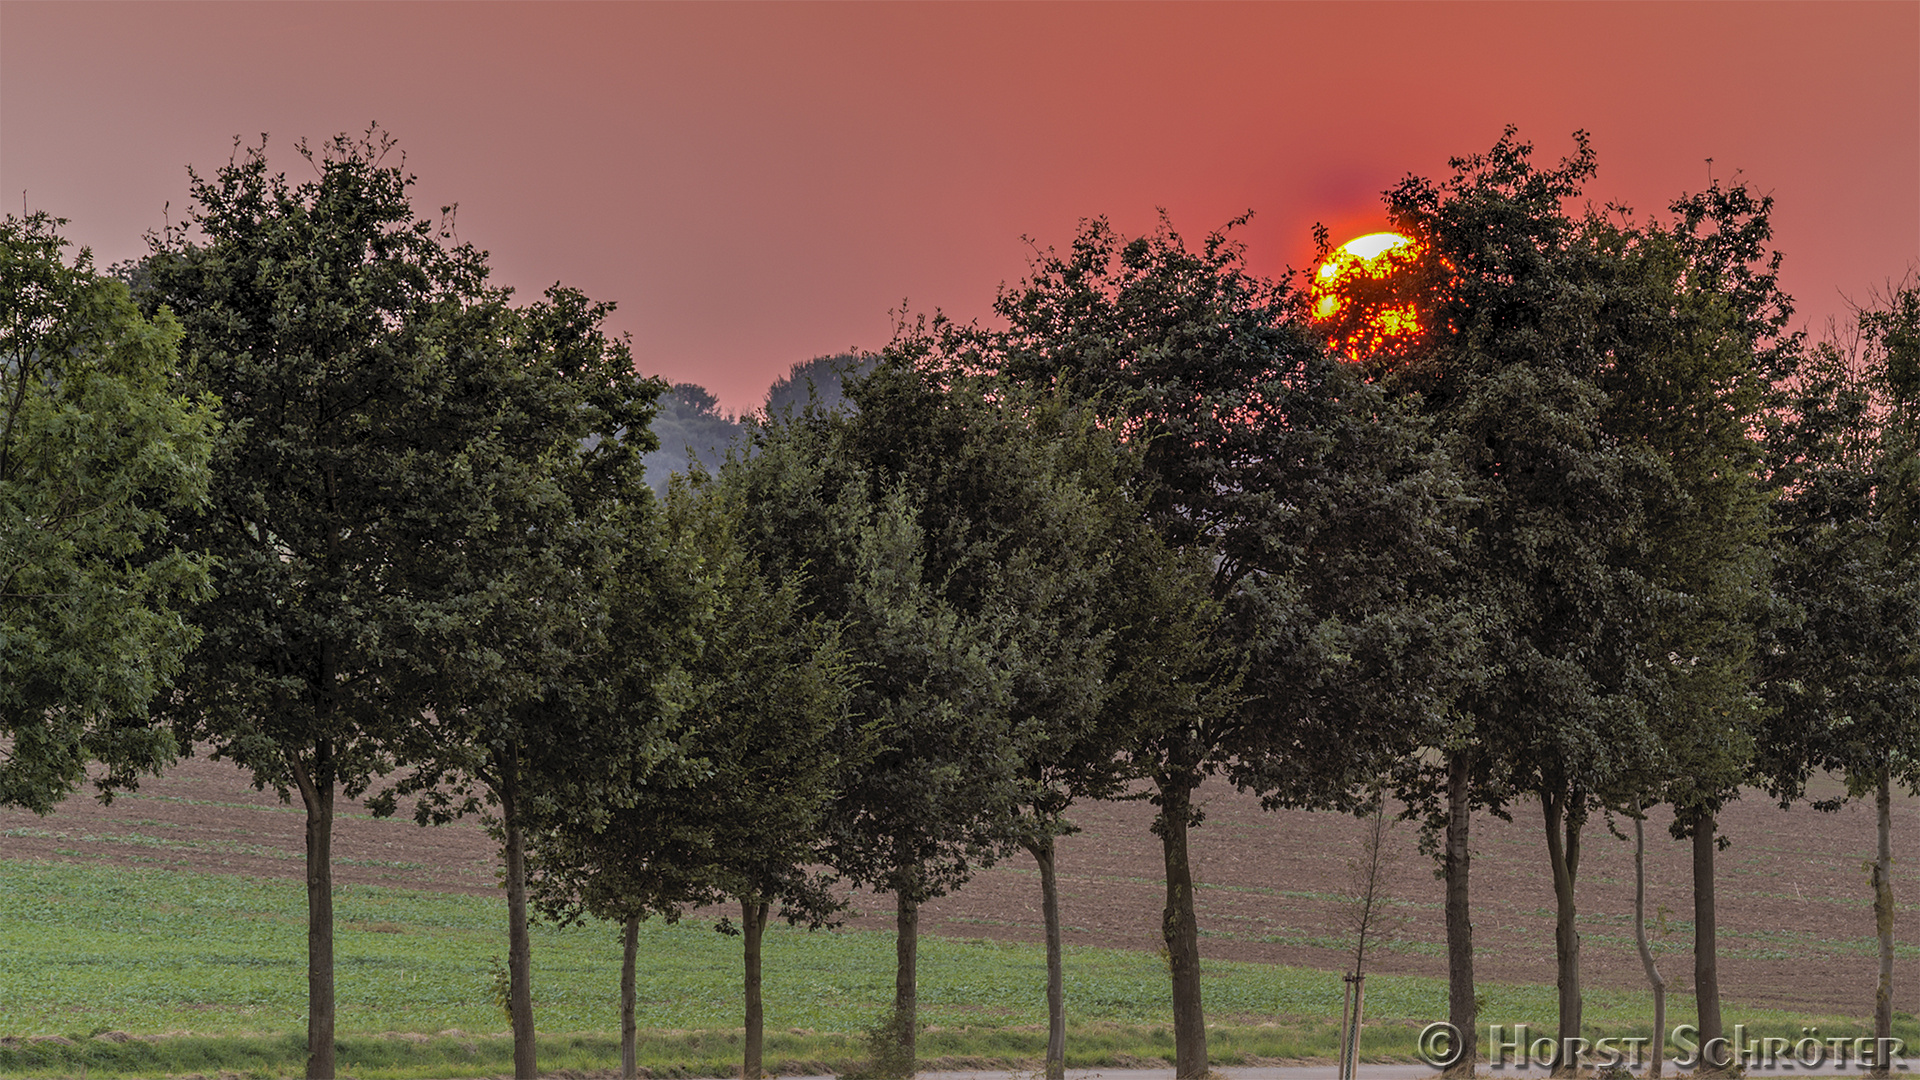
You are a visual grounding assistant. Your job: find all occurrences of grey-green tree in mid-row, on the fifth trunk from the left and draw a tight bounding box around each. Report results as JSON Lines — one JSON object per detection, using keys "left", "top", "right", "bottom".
{"left": 725, "top": 357, "right": 1110, "bottom": 1072}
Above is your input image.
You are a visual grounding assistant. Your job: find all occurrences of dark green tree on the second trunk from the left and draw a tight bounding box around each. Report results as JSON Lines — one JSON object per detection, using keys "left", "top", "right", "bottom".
{"left": 376, "top": 286, "right": 672, "bottom": 1078}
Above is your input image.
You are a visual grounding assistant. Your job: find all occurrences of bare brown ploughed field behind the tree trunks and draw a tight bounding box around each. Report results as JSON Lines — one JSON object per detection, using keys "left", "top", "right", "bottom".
{"left": 0, "top": 759, "right": 1920, "bottom": 1020}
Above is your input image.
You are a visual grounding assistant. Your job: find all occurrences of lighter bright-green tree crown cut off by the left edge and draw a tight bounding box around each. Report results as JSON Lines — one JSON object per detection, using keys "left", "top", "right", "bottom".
{"left": 0, "top": 213, "right": 217, "bottom": 815}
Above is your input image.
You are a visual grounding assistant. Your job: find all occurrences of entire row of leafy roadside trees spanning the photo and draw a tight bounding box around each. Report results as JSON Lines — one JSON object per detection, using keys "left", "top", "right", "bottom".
{"left": 0, "top": 131, "right": 1920, "bottom": 1078}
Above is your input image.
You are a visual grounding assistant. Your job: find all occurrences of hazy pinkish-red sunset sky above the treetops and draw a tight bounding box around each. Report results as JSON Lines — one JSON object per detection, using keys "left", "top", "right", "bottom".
{"left": 0, "top": 0, "right": 1920, "bottom": 411}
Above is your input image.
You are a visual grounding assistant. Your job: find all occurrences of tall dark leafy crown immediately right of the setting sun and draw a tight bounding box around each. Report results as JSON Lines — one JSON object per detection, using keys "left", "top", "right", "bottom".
{"left": 1388, "top": 129, "right": 1667, "bottom": 822}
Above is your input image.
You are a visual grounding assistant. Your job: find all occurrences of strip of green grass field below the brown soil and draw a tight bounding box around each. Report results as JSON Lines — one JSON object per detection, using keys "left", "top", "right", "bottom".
{"left": 0, "top": 861, "right": 1920, "bottom": 1078}
